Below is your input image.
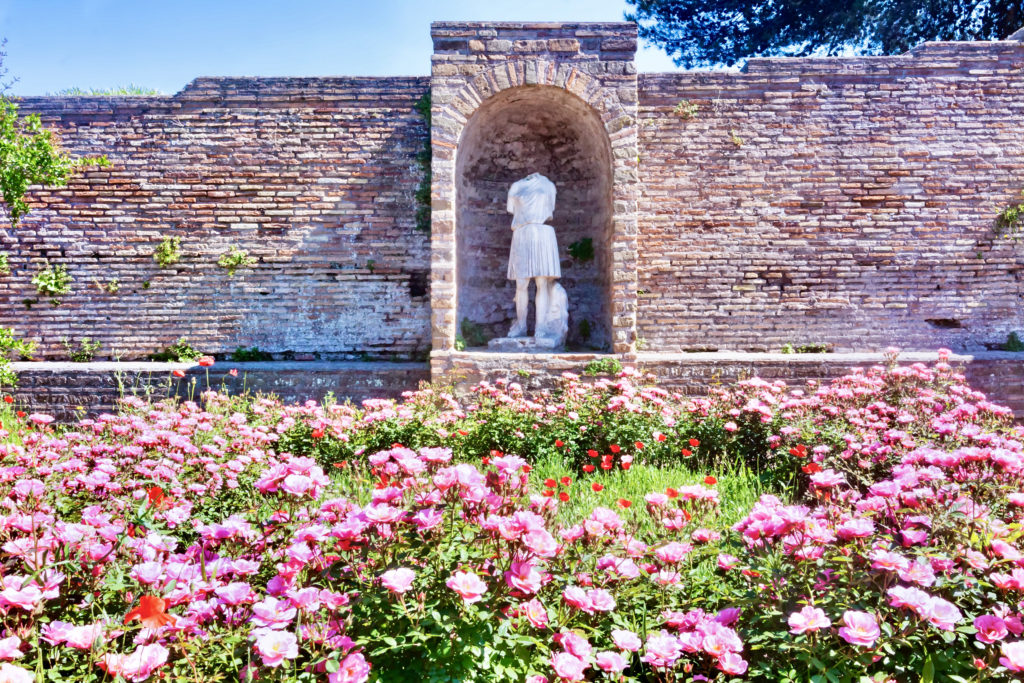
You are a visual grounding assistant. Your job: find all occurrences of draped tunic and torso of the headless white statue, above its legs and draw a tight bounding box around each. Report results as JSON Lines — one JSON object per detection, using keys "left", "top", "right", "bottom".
{"left": 508, "top": 173, "right": 562, "bottom": 280}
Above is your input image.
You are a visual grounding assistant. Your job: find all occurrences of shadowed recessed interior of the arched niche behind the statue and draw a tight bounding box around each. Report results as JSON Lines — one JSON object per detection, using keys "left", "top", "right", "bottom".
{"left": 456, "top": 85, "right": 612, "bottom": 350}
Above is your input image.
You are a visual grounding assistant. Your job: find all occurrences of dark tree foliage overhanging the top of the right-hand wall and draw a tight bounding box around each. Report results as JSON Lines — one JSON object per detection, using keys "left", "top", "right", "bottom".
{"left": 627, "top": 0, "right": 1024, "bottom": 68}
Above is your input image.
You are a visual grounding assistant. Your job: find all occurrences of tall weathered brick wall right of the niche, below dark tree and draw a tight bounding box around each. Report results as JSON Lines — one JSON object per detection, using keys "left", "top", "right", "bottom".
{"left": 637, "top": 41, "right": 1024, "bottom": 351}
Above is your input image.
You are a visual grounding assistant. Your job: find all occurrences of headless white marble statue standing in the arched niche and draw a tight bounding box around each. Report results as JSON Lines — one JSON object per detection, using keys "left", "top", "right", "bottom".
{"left": 495, "top": 173, "right": 568, "bottom": 349}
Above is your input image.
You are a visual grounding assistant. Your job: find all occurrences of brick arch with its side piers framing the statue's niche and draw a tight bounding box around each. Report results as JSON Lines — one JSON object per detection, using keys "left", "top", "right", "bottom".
{"left": 431, "top": 46, "right": 637, "bottom": 362}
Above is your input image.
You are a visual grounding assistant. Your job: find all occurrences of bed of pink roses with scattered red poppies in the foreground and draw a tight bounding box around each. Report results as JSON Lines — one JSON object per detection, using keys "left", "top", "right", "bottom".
{"left": 0, "top": 353, "right": 1024, "bottom": 683}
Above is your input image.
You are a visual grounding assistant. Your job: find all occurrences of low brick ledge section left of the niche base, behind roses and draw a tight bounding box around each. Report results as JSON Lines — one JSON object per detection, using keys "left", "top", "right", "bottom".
{"left": 13, "top": 361, "right": 430, "bottom": 420}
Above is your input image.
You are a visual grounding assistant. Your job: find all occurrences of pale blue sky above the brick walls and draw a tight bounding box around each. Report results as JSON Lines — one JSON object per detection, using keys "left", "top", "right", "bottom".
{"left": 0, "top": 0, "right": 688, "bottom": 95}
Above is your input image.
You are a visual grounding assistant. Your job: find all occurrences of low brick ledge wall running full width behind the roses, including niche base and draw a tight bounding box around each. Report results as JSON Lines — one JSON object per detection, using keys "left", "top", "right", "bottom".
{"left": 14, "top": 351, "right": 1024, "bottom": 420}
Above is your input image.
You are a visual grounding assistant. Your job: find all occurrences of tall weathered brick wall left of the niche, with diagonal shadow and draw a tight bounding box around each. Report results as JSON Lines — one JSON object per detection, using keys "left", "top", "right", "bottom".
{"left": 0, "top": 78, "right": 430, "bottom": 359}
